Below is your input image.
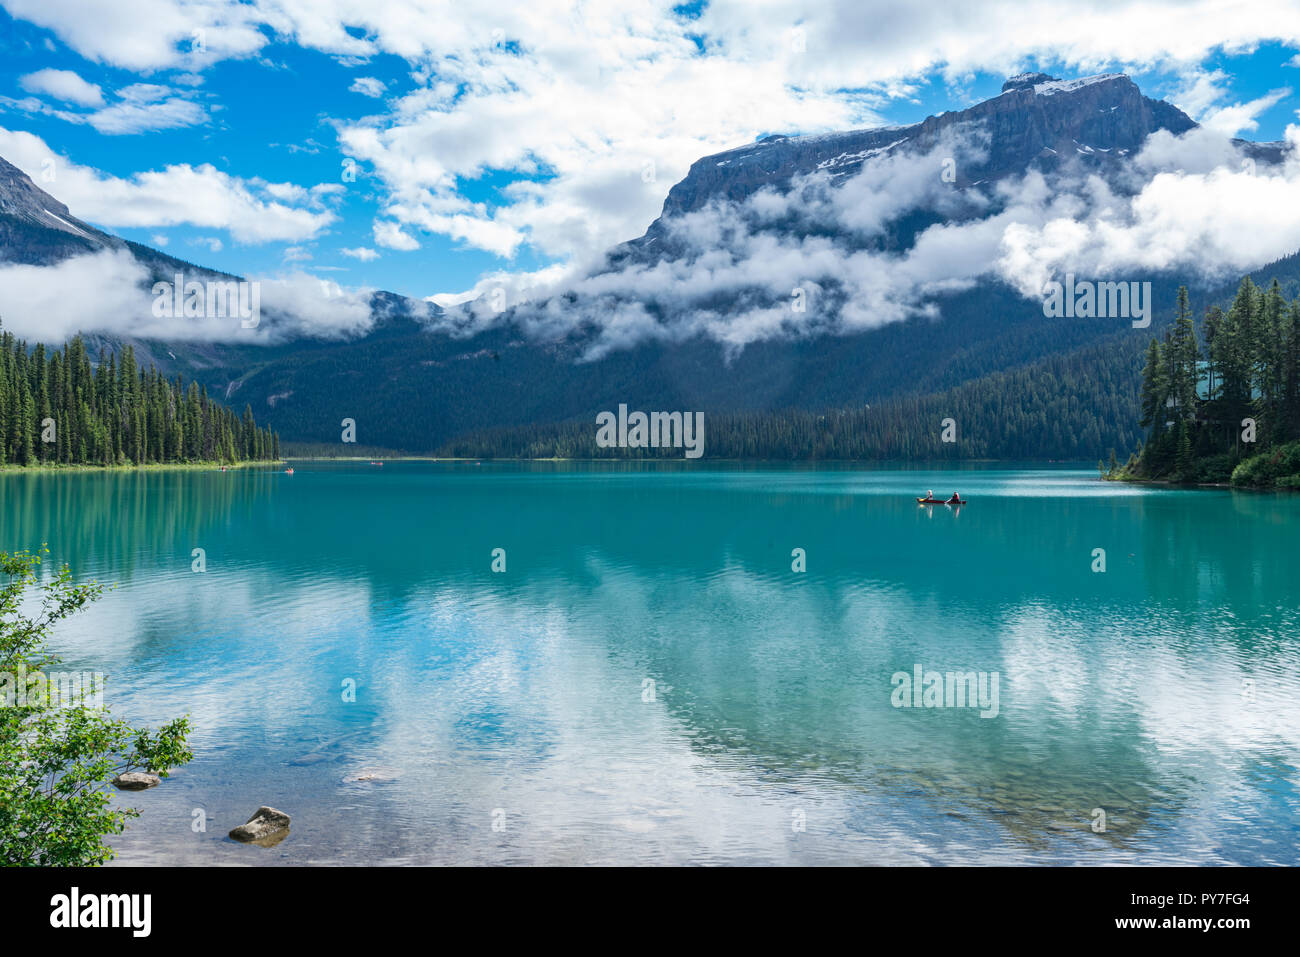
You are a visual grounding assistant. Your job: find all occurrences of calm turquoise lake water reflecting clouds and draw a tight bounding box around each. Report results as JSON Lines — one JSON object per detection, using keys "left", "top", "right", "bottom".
{"left": 0, "top": 463, "right": 1300, "bottom": 865}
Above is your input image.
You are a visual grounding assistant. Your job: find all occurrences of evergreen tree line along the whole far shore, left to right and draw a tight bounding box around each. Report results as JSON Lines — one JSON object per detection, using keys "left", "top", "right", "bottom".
{"left": 0, "top": 277, "right": 1300, "bottom": 489}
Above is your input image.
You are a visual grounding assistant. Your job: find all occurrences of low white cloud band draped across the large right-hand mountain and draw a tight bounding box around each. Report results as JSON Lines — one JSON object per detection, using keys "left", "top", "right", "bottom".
{"left": 434, "top": 121, "right": 1300, "bottom": 359}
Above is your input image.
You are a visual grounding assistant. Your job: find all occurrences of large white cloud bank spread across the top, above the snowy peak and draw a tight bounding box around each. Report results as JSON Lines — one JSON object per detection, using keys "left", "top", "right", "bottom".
{"left": 15, "top": 0, "right": 1300, "bottom": 273}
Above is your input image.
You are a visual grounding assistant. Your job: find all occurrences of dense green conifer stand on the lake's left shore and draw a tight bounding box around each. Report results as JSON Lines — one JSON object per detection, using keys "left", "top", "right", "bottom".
{"left": 0, "top": 325, "right": 280, "bottom": 465}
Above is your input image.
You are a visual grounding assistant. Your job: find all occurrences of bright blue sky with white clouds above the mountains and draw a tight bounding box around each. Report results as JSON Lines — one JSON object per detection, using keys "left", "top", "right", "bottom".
{"left": 0, "top": 0, "right": 1300, "bottom": 296}
